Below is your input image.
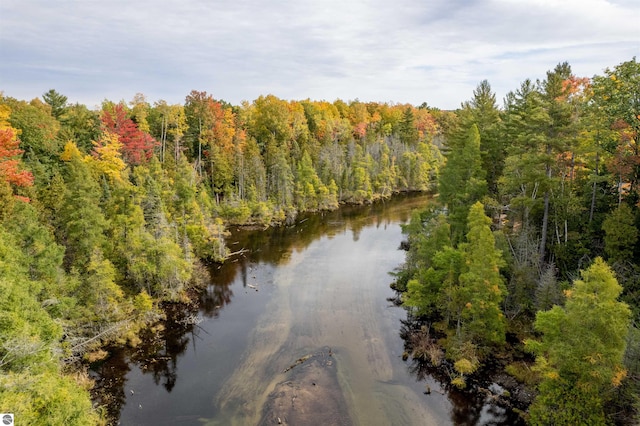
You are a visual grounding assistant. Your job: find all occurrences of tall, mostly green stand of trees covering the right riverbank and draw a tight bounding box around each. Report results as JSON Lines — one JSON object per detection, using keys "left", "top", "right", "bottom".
{"left": 394, "top": 58, "right": 640, "bottom": 425}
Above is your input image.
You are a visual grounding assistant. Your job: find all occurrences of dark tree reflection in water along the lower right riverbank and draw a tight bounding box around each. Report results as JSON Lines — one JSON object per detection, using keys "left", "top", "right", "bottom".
{"left": 400, "top": 319, "right": 524, "bottom": 426}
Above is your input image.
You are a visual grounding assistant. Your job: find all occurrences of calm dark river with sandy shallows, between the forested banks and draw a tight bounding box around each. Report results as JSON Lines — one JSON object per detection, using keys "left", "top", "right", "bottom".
{"left": 92, "top": 196, "right": 520, "bottom": 426}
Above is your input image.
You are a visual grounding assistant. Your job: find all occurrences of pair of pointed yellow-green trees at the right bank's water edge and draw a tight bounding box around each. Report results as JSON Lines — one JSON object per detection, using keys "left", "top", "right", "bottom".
{"left": 402, "top": 202, "right": 506, "bottom": 364}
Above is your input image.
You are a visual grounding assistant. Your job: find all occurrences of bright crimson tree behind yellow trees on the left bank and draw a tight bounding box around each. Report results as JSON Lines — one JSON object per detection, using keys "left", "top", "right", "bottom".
{"left": 101, "top": 104, "right": 158, "bottom": 166}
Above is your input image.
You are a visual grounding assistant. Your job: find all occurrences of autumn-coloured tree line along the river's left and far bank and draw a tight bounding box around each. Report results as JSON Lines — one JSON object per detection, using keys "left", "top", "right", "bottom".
{"left": 0, "top": 90, "right": 442, "bottom": 425}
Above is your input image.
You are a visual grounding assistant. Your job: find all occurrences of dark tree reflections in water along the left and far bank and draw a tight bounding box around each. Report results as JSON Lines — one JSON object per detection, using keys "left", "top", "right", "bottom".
{"left": 91, "top": 195, "right": 432, "bottom": 424}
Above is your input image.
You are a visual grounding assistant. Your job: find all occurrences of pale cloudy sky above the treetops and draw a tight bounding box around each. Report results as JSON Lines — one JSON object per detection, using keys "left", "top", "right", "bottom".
{"left": 0, "top": 0, "right": 640, "bottom": 109}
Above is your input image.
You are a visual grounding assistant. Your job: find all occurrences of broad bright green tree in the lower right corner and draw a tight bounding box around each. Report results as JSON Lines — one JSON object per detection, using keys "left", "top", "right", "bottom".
{"left": 527, "top": 258, "right": 630, "bottom": 424}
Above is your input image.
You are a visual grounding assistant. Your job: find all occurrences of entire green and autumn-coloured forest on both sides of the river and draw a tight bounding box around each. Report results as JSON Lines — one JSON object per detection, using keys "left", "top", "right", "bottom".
{"left": 0, "top": 58, "right": 640, "bottom": 425}
